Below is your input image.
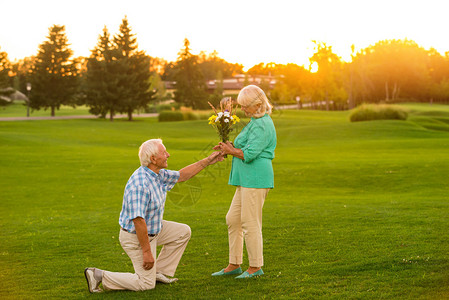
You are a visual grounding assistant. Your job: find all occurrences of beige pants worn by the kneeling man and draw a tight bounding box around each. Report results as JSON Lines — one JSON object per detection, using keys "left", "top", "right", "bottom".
{"left": 102, "top": 221, "right": 191, "bottom": 291}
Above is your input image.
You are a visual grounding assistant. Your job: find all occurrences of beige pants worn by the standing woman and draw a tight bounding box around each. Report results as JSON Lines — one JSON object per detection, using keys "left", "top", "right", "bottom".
{"left": 226, "top": 187, "right": 269, "bottom": 268}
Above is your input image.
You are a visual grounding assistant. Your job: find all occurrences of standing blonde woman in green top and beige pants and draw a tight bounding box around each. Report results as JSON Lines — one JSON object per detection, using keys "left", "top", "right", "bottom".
{"left": 212, "top": 85, "right": 276, "bottom": 279}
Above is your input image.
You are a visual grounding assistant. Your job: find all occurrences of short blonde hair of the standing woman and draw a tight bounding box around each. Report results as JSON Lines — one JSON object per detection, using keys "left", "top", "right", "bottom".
{"left": 237, "top": 85, "right": 273, "bottom": 118}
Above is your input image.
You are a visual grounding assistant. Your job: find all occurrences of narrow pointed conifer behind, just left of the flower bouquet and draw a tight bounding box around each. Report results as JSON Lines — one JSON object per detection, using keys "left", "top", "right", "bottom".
{"left": 174, "top": 39, "right": 208, "bottom": 109}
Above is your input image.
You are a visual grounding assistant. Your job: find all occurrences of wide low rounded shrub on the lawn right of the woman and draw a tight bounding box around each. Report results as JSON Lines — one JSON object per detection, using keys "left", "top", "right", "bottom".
{"left": 349, "top": 104, "right": 408, "bottom": 122}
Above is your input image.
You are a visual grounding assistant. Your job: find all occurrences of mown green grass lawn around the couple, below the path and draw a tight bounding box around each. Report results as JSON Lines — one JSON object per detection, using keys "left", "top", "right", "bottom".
{"left": 0, "top": 104, "right": 449, "bottom": 299}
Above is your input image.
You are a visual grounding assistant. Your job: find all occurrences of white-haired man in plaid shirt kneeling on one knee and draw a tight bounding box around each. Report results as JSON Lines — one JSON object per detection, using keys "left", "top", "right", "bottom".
{"left": 84, "top": 139, "right": 223, "bottom": 293}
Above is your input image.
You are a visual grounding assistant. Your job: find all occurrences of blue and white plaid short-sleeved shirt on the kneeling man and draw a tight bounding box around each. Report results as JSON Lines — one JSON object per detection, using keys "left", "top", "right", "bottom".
{"left": 119, "top": 166, "right": 179, "bottom": 234}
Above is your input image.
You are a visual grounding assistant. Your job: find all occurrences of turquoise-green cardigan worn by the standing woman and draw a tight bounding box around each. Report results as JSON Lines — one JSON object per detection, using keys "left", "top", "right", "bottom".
{"left": 229, "top": 114, "right": 276, "bottom": 188}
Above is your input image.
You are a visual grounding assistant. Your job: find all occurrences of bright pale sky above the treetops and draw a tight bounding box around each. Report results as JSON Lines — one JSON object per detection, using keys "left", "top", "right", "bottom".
{"left": 0, "top": 0, "right": 449, "bottom": 70}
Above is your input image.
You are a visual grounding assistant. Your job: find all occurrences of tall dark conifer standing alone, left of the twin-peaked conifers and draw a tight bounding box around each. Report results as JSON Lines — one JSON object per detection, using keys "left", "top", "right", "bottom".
{"left": 30, "top": 25, "right": 78, "bottom": 116}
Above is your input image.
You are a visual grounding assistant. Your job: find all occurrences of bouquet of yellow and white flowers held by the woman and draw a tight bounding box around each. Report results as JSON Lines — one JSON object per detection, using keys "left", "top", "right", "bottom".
{"left": 208, "top": 97, "right": 240, "bottom": 143}
